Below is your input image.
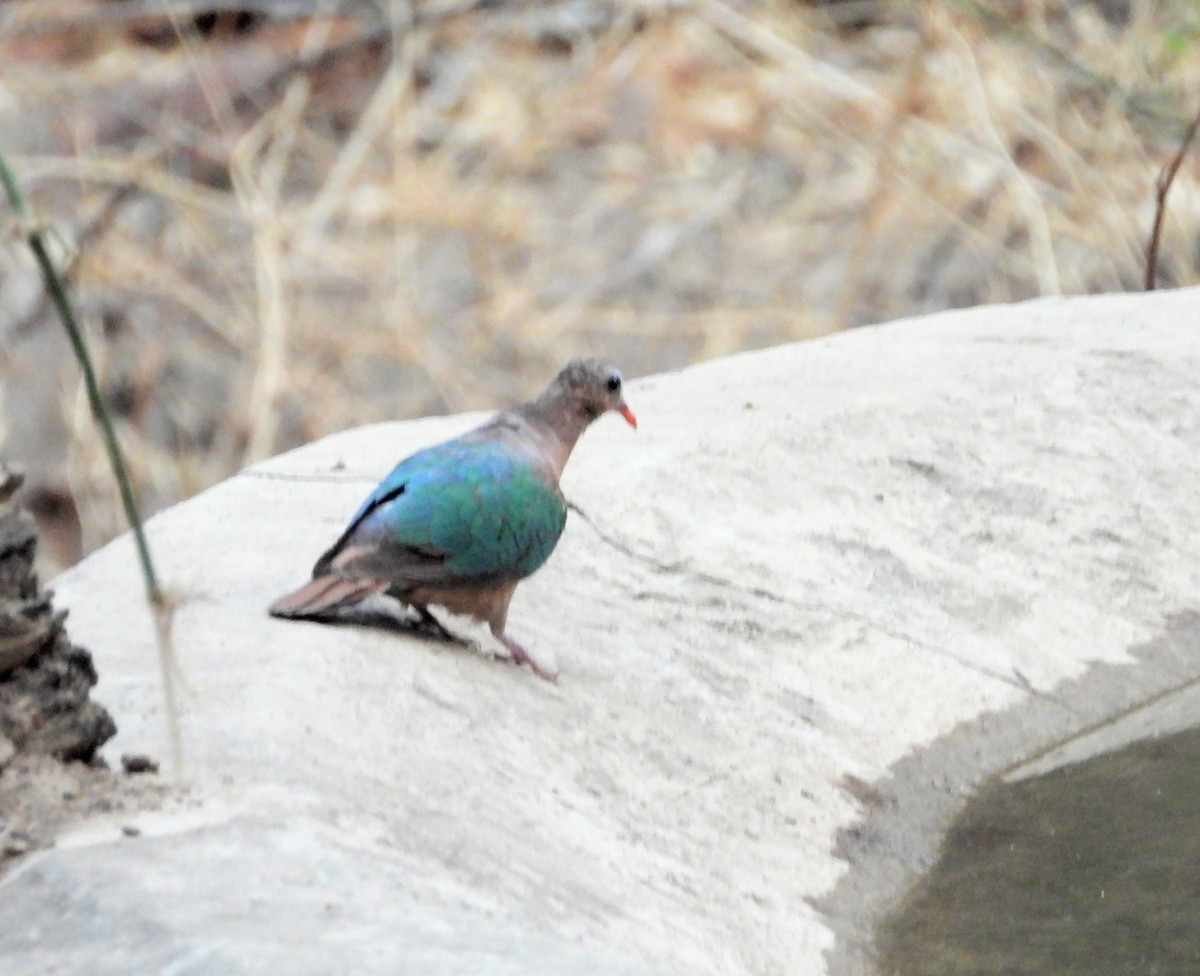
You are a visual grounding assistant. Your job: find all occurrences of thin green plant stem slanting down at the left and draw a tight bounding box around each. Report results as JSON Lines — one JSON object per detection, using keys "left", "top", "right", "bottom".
{"left": 0, "top": 152, "right": 164, "bottom": 606}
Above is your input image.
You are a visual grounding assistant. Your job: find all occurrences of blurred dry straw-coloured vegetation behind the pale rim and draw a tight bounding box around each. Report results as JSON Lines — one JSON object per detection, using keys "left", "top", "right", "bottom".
{"left": 0, "top": 0, "right": 1200, "bottom": 573}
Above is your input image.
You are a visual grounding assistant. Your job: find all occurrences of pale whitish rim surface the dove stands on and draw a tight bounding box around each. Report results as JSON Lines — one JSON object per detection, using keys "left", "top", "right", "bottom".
{"left": 7, "top": 292, "right": 1200, "bottom": 976}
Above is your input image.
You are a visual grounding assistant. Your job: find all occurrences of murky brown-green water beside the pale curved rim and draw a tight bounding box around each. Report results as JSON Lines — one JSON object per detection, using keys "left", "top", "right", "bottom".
{"left": 877, "top": 729, "right": 1200, "bottom": 976}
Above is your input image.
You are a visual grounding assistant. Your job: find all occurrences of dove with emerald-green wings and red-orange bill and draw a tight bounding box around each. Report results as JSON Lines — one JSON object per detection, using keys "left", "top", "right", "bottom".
{"left": 269, "top": 359, "right": 637, "bottom": 681}
